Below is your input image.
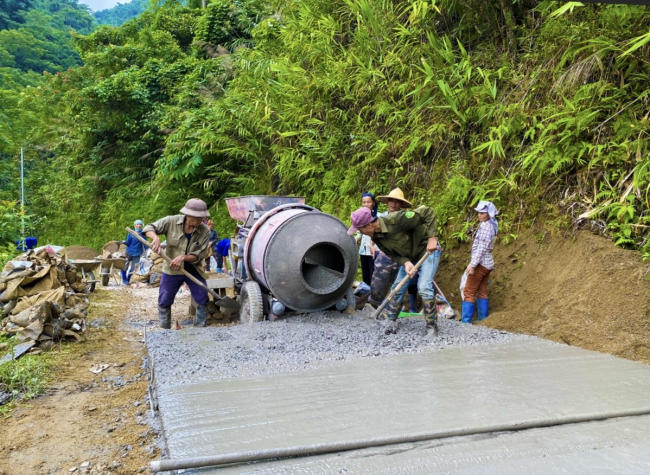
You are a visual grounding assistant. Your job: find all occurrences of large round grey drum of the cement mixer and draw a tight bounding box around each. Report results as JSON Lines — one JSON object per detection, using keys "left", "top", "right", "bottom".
{"left": 244, "top": 204, "right": 358, "bottom": 312}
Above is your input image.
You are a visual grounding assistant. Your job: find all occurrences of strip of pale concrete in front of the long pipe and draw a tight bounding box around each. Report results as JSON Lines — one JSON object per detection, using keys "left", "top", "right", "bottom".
{"left": 206, "top": 416, "right": 650, "bottom": 475}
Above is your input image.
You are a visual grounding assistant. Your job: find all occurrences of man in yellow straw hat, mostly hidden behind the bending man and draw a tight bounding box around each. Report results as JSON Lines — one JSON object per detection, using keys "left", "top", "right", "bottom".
{"left": 368, "top": 188, "right": 413, "bottom": 308}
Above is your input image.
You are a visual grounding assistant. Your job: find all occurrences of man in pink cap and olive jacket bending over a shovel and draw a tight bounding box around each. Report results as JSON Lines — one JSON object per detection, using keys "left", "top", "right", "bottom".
{"left": 348, "top": 195, "right": 440, "bottom": 337}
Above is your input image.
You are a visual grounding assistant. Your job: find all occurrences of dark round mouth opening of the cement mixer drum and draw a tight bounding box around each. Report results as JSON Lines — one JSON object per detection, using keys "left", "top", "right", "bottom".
{"left": 300, "top": 243, "right": 346, "bottom": 294}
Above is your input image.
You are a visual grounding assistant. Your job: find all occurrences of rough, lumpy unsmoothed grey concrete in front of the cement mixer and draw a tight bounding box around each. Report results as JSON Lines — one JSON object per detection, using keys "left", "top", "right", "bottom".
{"left": 146, "top": 310, "right": 534, "bottom": 386}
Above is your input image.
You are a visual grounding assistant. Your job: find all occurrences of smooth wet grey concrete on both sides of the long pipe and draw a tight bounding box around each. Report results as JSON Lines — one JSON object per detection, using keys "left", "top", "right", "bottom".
{"left": 153, "top": 339, "right": 650, "bottom": 473}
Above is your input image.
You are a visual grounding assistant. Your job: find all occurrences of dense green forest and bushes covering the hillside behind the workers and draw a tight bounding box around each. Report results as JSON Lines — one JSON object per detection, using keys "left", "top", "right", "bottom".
{"left": 0, "top": 0, "right": 650, "bottom": 259}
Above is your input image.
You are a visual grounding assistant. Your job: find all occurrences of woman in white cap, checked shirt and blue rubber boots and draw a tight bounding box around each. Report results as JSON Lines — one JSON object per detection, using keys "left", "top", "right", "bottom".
{"left": 462, "top": 201, "right": 499, "bottom": 323}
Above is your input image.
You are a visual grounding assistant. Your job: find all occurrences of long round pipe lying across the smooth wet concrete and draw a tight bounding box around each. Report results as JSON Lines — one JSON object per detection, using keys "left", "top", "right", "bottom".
{"left": 150, "top": 408, "right": 650, "bottom": 473}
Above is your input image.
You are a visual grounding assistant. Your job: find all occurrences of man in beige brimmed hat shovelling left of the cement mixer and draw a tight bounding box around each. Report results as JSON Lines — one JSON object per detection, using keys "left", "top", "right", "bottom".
{"left": 143, "top": 198, "right": 210, "bottom": 329}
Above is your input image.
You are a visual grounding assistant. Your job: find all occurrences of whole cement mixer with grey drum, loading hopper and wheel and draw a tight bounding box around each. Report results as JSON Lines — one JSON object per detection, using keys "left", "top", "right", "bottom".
{"left": 221, "top": 195, "right": 358, "bottom": 323}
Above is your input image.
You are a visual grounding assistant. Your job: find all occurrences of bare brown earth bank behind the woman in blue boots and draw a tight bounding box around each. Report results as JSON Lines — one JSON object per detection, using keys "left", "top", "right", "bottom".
{"left": 436, "top": 231, "right": 650, "bottom": 364}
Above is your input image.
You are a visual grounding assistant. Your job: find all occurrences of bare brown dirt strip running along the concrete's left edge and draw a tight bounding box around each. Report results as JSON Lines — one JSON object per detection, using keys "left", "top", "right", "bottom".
{"left": 0, "top": 284, "right": 189, "bottom": 475}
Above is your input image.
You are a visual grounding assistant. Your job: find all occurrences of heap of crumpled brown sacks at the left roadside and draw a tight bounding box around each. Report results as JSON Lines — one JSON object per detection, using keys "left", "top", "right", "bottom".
{"left": 0, "top": 246, "right": 89, "bottom": 352}
